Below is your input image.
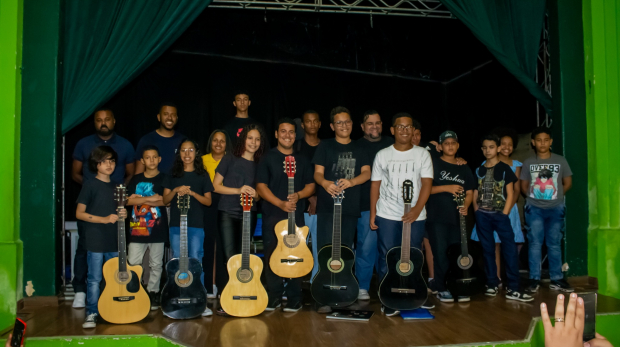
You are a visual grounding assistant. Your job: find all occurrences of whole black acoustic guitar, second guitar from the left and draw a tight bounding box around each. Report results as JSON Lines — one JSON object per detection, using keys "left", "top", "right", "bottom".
{"left": 161, "top": 195, "right": 207, "bottom": 319}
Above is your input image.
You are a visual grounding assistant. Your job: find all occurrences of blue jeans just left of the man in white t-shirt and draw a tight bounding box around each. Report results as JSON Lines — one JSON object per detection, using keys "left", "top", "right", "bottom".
{"left": 355, "top": 211, "right": 379, "bottom": 290}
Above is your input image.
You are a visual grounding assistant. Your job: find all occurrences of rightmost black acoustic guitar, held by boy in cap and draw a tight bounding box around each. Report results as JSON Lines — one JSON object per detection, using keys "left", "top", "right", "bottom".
{"left": 446, "top": 192, "right": 486, "bottom": 301}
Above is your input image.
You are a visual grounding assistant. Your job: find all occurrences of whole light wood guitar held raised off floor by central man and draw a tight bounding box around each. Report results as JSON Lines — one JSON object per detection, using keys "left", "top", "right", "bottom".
{"left": 269, "top": 155, "right": 314, "bottom": 278}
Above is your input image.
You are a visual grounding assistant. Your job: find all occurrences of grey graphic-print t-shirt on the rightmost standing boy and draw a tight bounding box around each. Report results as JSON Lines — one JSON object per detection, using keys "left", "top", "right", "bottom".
{"left": 520, "top": 153, "right": 573, "bottom": 208}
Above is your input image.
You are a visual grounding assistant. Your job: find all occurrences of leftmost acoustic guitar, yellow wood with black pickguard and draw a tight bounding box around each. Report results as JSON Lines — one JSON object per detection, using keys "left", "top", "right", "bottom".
{"left": 97, "top": 184, "right": 151, "bottom": 324}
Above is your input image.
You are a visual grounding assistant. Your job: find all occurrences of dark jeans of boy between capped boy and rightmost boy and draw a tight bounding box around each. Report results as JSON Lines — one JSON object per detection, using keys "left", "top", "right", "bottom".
{"left": 476, "top": 210, "right": 519, "bottom": 291}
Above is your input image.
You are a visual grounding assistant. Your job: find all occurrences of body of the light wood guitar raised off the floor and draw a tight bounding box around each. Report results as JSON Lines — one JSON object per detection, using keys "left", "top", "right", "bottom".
{"left": 269, "top": 219, "right": 314, "bottom": 278}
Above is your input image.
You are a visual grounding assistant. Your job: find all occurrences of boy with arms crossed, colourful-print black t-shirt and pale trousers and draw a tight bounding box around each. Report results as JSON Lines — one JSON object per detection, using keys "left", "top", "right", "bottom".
{"left": 127, "top": 145, "right": 168, "bottom": 310}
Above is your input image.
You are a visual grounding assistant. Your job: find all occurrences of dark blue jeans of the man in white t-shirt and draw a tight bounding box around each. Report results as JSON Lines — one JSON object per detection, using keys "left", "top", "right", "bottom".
{"left": 375, "top": 216, "right": 426, "bottom": 282}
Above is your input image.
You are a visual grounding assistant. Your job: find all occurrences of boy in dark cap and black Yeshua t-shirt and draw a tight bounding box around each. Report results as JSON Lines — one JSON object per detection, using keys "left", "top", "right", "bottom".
{"left": 426, "top": 131, "right": 476, "bottom": 302}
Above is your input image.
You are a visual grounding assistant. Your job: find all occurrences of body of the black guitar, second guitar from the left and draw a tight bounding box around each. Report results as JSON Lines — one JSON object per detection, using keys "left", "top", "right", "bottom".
{"left": 161, "top": 258, "right": 207, "bottom": 319}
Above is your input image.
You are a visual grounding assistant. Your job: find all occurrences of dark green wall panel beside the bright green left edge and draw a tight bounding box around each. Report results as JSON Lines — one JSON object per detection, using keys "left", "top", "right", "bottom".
{"left": 20, "top": 0, "right": 62, "bottom": 295}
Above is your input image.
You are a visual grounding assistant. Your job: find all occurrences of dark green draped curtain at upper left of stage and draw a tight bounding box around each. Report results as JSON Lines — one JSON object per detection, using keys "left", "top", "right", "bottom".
{"left": 62, "top": 0, "right": 211, "bottom": 134}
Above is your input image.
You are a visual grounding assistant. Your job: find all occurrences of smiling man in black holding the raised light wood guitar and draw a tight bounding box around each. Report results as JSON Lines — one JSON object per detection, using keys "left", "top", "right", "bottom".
{"left": 256, "top": 118, "right": 315, "bottom": 312}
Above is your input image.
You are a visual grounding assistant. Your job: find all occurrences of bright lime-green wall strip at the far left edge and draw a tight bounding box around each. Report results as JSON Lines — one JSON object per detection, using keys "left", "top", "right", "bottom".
{"left": 0, "top": 0, "right": 23, "bottom": 332}
